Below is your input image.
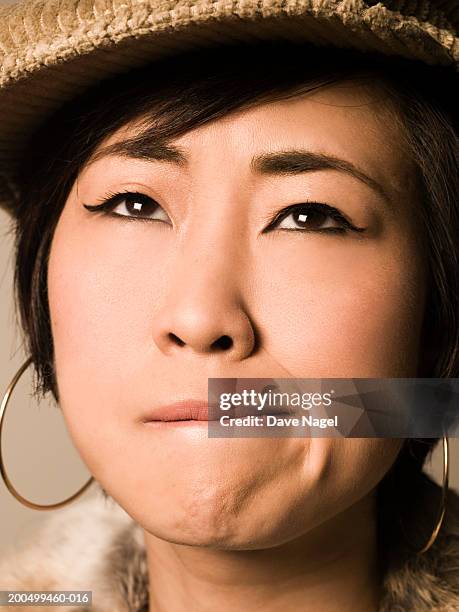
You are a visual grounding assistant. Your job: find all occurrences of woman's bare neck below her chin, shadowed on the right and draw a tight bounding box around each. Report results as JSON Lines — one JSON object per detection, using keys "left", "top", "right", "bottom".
{"left": 145, "top": 496, "right": 380, "bottom": 612}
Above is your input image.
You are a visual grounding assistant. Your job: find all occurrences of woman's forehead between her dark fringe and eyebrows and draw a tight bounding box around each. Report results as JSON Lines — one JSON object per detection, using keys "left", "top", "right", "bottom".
{"left": 88, "top": 81, "right": 413, "bottom": 189}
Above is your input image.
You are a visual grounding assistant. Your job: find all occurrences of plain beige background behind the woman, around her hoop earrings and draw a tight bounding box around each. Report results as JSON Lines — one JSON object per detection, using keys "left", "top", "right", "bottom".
{"left": 0, "top": 204, "right": 459, "bottom": 552}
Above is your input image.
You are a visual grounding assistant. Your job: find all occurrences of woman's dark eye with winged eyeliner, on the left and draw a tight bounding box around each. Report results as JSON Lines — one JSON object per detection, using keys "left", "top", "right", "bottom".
{"left": 83, "top": 191, "right": 172, "bottom": 225}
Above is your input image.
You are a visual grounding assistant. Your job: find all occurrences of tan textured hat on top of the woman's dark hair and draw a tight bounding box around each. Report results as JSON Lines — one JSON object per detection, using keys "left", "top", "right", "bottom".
{"left": 0, "top": 0, "right": 459, "bottom": 213}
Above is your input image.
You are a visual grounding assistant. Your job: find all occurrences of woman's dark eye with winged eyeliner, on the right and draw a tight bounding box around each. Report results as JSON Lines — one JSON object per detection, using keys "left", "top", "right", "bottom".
{"left": 264, "top": 202, "right": 365, "bottom": 233}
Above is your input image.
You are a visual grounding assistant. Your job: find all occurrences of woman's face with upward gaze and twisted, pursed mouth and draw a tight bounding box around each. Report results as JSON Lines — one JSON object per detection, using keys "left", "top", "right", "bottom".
{"left": 48, "top": 77, "right": 425, "bottom": 549}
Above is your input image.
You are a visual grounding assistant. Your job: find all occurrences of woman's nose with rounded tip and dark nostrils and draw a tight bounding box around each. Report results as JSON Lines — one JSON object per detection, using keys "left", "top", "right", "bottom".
{"left": 153, "top": 245, "right": 256, "bottom": 361}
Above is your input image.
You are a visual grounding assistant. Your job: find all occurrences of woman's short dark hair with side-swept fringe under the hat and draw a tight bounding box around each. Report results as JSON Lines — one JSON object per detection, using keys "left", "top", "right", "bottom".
{"left": 9, "top": 42, "right": 459, "bottom": 520}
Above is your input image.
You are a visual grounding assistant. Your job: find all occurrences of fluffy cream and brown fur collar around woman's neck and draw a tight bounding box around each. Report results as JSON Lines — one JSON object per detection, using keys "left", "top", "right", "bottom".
{"left": 0, "top": 476, "right": 459, "bottom": 612}
